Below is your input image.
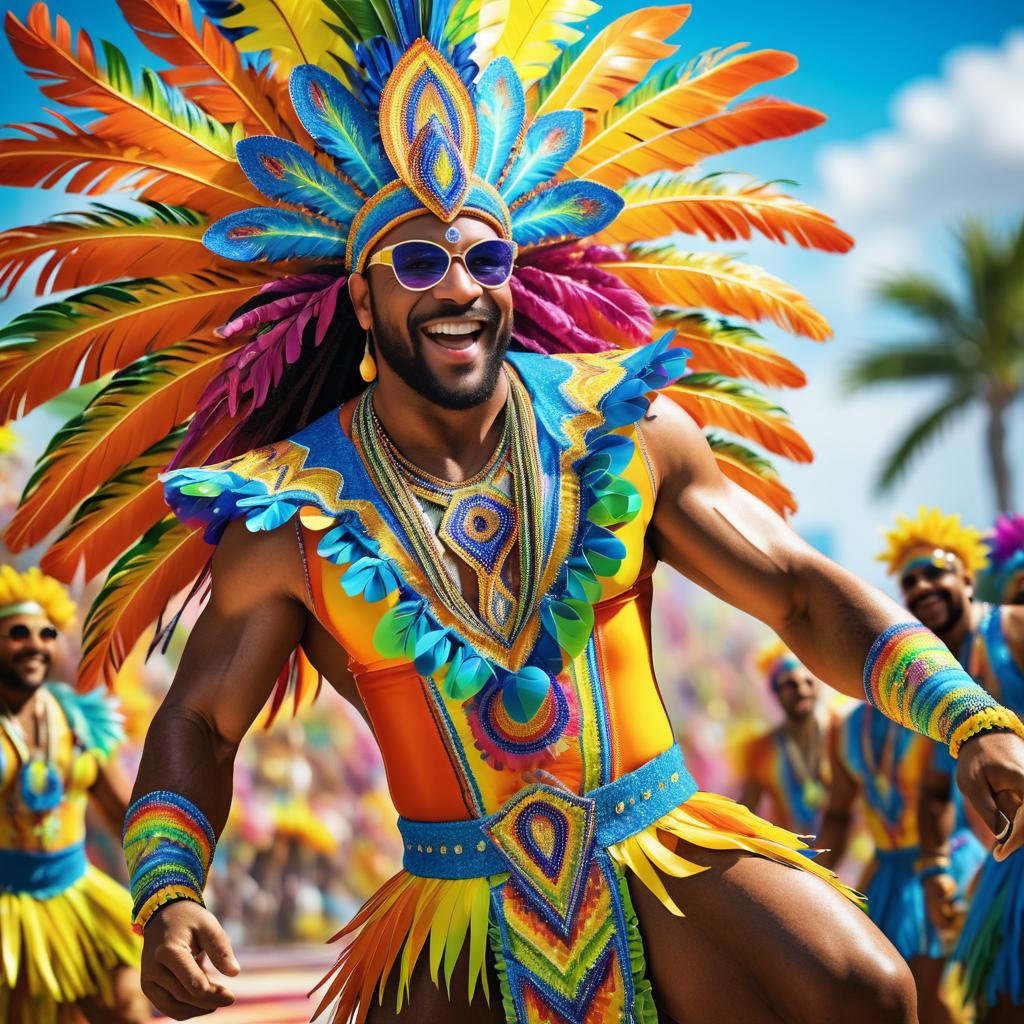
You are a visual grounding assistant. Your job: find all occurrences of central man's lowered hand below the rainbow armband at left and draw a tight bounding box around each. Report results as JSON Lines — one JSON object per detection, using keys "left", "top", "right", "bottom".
{"left": 142, "top": 900, "right": 239, "bottom": 1021}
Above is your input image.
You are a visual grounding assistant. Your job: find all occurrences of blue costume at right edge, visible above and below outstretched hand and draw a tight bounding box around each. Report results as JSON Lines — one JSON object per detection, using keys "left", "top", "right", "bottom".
{"left": 952, "top": 606, "right": 1024, "bottom": 1019}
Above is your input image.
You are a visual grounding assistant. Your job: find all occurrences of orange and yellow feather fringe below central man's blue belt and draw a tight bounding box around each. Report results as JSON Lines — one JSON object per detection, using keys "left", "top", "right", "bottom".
{"left": 317, "top": 792, "right": 862, "bottom": 1024}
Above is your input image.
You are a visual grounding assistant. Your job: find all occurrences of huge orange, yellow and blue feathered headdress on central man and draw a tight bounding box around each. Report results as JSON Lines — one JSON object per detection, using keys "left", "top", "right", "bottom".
{"left": 0, "top": 0, "right": 852, "bottom": 686}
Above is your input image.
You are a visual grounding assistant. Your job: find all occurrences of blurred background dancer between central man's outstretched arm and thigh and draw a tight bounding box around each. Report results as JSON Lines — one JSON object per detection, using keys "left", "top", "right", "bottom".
{"left": 739, "top": 641, "right": 830, "bottom": 836}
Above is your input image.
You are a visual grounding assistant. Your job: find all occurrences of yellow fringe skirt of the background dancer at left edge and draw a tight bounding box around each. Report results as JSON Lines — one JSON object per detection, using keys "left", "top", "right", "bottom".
{"left": 0, "top": 865, "right": 141, "bottom": 1024}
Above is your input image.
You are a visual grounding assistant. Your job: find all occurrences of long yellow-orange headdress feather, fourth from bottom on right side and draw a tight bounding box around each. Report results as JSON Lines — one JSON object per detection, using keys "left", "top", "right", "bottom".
{"left": 605, "top": 246, "right": 831, "bottom": 341}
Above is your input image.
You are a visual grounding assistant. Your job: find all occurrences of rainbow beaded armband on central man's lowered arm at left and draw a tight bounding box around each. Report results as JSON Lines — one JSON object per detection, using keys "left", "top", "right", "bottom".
{"left": 122, "top": 790, "right": 217, "bottom": 934}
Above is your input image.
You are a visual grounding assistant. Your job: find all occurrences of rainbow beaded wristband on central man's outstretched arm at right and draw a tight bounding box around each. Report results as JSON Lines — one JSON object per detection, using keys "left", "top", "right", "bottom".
{"left": 864, "top": 623, "right": 1024, "bottom": 757}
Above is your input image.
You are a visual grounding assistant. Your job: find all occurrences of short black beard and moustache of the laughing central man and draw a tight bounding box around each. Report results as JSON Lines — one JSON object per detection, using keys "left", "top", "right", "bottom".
{"left": 371, "top": 300, "right": 512, "bottom": 409}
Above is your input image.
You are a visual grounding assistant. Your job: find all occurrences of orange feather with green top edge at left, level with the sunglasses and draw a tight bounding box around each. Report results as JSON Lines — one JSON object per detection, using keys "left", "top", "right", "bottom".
{"left": 0, "top": 203, "right": 211, "bottom": 295}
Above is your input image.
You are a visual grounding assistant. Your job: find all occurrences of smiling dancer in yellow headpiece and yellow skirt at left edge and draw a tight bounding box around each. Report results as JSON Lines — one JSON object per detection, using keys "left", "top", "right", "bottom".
{"left": 0, "top": 565, "right": 152, "bottom": 1024}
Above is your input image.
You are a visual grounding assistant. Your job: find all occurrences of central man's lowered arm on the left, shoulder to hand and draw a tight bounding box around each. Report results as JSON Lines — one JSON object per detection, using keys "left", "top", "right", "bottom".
{"left": 125, "top": 522, "right": 306, "bottom": 1020}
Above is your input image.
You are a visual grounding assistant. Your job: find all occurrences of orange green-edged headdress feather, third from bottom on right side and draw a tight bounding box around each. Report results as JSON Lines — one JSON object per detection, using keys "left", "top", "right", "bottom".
{"left": 652, "top": 306, "right": 807, "bottom": 387}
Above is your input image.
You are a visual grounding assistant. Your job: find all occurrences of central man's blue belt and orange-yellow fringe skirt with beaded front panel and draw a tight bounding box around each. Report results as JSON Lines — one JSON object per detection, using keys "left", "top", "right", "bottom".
{"left": 317, "top": 746, "right": 856, "bottom": 1024}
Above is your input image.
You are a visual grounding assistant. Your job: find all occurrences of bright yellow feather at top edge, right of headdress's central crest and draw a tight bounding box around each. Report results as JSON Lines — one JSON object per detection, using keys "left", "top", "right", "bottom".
{"left": 495, "top": 0, "right": 601, "bottom": 88}
